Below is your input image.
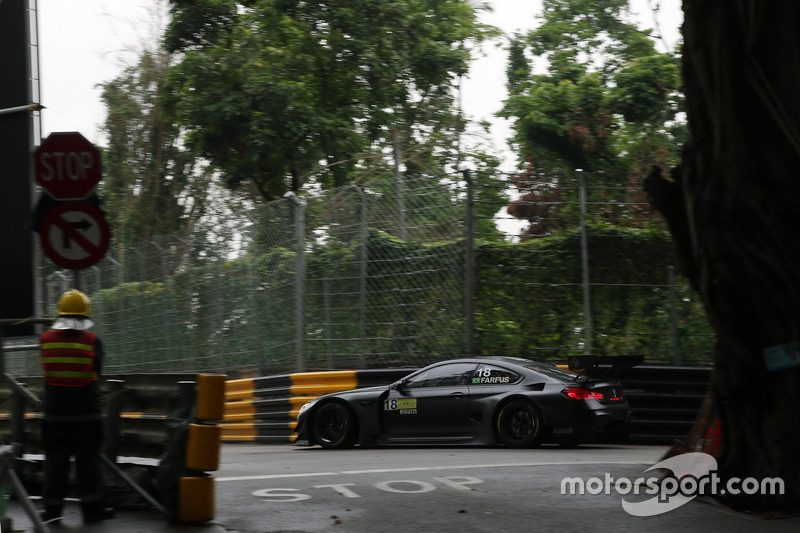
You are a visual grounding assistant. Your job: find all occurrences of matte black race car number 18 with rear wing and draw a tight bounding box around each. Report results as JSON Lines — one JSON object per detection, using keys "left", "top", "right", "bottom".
{"left": 295, "top": 356, "right": 641, "bottom": 449}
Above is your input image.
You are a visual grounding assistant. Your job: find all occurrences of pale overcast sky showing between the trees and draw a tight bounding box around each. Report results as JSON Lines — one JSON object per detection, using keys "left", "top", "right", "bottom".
{"left": 32, "top": 0, "right": 681, "bottom": 166}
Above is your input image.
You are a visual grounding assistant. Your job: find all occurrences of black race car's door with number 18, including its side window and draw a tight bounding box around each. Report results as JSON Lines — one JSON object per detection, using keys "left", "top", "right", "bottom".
{"left": 383, "top": 363, "right": 477, "bottom": 439}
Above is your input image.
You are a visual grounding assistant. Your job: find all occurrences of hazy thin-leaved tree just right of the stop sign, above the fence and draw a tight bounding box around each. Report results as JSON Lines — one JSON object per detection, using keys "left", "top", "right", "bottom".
{"left": 99, "top": 43, "right": 264, "bottom": 277}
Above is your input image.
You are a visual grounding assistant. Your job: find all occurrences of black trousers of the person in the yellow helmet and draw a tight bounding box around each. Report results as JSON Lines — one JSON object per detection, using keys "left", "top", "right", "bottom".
{"left": 42, "top": 420, "right": 103, "bottom": 511}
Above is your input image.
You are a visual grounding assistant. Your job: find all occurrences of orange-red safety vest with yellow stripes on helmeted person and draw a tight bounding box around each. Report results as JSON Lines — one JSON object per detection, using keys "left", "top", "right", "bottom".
{"left": 42, "top": 330, "right": 98, "bottom": 387}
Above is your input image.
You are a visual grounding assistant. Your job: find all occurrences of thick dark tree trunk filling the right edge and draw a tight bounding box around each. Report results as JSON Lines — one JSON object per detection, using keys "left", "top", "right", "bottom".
{"left": 648, "top": 0, "right": 800, "bottom": 512}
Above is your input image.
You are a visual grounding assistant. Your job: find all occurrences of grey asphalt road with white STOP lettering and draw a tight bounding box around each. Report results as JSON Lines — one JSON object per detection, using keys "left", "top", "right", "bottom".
{"left": 209, "top": 445, "right": 800, "bottom": 533}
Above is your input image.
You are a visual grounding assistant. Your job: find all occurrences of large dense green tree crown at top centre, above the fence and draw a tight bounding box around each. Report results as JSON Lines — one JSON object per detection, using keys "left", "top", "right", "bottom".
{"left": 165, "top": 0, "right": 488, "bottom": 199}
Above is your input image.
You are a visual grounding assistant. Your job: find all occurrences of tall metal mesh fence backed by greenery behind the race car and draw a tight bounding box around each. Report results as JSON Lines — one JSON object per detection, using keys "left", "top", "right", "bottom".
{"left": 19, "top": 169, "right": 713, "bottom": 375}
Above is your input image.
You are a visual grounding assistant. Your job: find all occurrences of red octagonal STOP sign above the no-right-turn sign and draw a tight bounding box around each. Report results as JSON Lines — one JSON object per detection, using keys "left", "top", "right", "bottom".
{"left": 33, "top": 132, "right": 103, "bottom": 200}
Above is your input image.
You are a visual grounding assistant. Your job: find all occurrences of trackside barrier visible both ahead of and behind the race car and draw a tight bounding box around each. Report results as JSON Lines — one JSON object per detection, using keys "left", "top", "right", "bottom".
{"left": 221, "top": 365, "right": 711, "bottom": 445}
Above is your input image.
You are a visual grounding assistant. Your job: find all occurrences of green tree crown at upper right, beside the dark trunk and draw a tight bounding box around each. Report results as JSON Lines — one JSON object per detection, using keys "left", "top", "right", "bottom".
{"left": 501, "top": 0, "right": 685, "bottom": 235}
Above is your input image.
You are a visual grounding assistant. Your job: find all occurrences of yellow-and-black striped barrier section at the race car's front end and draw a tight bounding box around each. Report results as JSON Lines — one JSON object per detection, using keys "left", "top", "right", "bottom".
{"left": 222, "top": 368, "right": 415, "bottom": 443}
